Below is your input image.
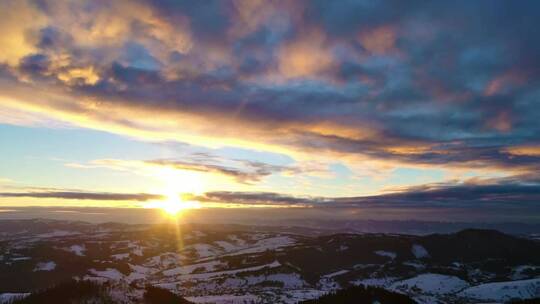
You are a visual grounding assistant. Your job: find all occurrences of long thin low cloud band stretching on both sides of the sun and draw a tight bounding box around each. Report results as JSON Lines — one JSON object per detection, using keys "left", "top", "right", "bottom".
{"left": 0, "top": 178, "right": 540, "bottom": 208}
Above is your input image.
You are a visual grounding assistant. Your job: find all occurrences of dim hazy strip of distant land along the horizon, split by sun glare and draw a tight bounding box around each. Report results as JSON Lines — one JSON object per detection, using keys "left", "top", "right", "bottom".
{"left": 0, "top": 207, "right": 540, "bottom": 238}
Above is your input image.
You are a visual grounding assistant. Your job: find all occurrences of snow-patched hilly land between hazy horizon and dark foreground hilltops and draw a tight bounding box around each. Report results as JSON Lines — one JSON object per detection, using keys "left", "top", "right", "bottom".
{"left": 0, "top": 220, "right": 540, "bottom": 303}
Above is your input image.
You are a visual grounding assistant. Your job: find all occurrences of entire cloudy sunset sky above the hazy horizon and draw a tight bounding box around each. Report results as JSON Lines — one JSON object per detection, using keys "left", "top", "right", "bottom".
{"left": 0, "top": 0, "right": 540, "bottom": 222}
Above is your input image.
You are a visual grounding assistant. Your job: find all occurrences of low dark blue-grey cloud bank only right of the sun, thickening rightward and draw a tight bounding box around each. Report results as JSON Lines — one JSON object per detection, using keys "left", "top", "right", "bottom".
{"left": 194, "top": 180, "right": 540, "bottom": 210}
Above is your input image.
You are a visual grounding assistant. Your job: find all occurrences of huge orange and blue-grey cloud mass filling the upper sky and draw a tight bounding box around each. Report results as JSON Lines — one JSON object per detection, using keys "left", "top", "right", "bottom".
{"left": 0, "top": 0, "right": 540, "bottom": 183}
